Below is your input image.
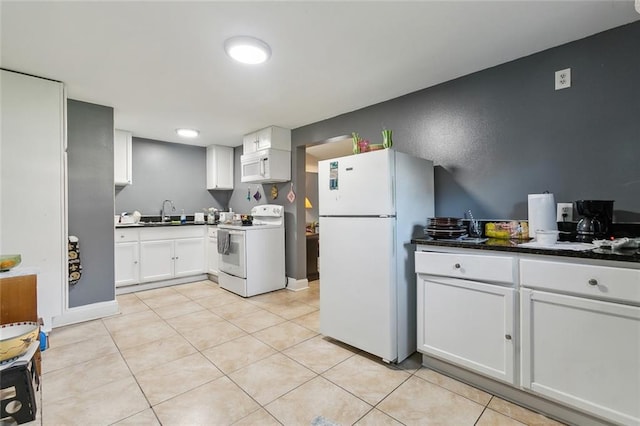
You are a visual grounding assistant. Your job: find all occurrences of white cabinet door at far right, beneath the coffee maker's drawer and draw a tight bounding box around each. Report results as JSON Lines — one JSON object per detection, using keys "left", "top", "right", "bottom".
{"left": 522, "top": 289, "right": 640, "bottom": 425}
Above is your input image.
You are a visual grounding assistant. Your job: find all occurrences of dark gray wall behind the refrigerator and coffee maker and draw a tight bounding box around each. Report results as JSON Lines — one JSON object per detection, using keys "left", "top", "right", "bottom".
{"left": 287, "top": 21, "right": 640, "bottom": 279}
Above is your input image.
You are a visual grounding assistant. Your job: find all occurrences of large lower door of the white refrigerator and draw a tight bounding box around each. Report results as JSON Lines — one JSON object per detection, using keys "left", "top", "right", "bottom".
{"left": 320, "top": 217, "right": 398, "bottom": 362}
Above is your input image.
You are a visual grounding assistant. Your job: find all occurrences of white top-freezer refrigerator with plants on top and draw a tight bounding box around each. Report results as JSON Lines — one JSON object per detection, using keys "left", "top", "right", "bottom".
{"left": 318, "top": 149, "right": 434, "bottom": 362}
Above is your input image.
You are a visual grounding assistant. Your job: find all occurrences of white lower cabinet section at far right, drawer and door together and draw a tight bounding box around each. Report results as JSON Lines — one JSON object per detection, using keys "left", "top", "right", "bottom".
{"left": 520, "top": 260, "right": 640, "bottom": 425}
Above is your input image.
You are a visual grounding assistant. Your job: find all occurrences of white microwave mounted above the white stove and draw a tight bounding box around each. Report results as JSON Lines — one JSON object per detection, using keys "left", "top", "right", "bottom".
{"left": 240, "top": 149, "right": 291, "bottom": 183}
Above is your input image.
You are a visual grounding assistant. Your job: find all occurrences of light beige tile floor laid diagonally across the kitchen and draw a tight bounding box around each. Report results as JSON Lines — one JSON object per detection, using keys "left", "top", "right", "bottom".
{"left": 25, "top": 281, "right": 560, "bottom": 426}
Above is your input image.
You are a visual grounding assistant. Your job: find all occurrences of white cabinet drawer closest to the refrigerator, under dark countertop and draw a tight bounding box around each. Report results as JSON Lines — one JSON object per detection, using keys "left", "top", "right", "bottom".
{"left": 416, "top": 251, "right": 514, "bottom": 283}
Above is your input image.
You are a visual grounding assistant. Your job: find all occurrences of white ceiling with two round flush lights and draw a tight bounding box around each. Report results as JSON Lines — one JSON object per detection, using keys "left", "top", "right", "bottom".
{"left": 0, "top": 0, "right": 640, "bottom": 146}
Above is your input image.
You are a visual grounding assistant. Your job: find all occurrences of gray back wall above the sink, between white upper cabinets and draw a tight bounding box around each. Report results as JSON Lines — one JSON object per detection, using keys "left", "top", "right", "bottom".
{"left": 115, "top": 137, "right": 230, "bottom": 216}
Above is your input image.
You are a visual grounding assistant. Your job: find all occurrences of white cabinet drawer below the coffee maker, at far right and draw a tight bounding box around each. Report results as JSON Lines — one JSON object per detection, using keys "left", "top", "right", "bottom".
{"left": 520, "top": 259, "right": 640, "bottom": 303}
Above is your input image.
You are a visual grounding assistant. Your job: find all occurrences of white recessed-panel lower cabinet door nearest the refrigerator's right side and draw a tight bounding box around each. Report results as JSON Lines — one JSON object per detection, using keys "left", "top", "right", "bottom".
{"left": 417, "top": 274, "right": 516, "bottom": 384}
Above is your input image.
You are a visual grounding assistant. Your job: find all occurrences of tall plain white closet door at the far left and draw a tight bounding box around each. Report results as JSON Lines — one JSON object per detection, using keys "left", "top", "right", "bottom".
{"left": 0, "top": 70, "right": 68, "bottom": 331}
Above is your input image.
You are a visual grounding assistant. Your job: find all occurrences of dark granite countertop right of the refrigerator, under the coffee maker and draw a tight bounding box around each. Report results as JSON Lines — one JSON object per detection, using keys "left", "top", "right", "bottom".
{"left": 411, "top": 237, "right": 640, "bottom": 262}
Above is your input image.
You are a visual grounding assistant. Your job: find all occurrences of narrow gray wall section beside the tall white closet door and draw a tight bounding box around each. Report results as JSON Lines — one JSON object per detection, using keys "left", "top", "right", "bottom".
{"left": 67, "top": 99, "right": 115, "bottom": 308}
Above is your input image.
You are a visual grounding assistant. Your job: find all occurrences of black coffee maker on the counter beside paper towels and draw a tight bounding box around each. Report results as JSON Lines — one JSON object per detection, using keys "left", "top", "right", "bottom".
{"left": 576, "top": 200, "right": 613, "bottom": 243}
